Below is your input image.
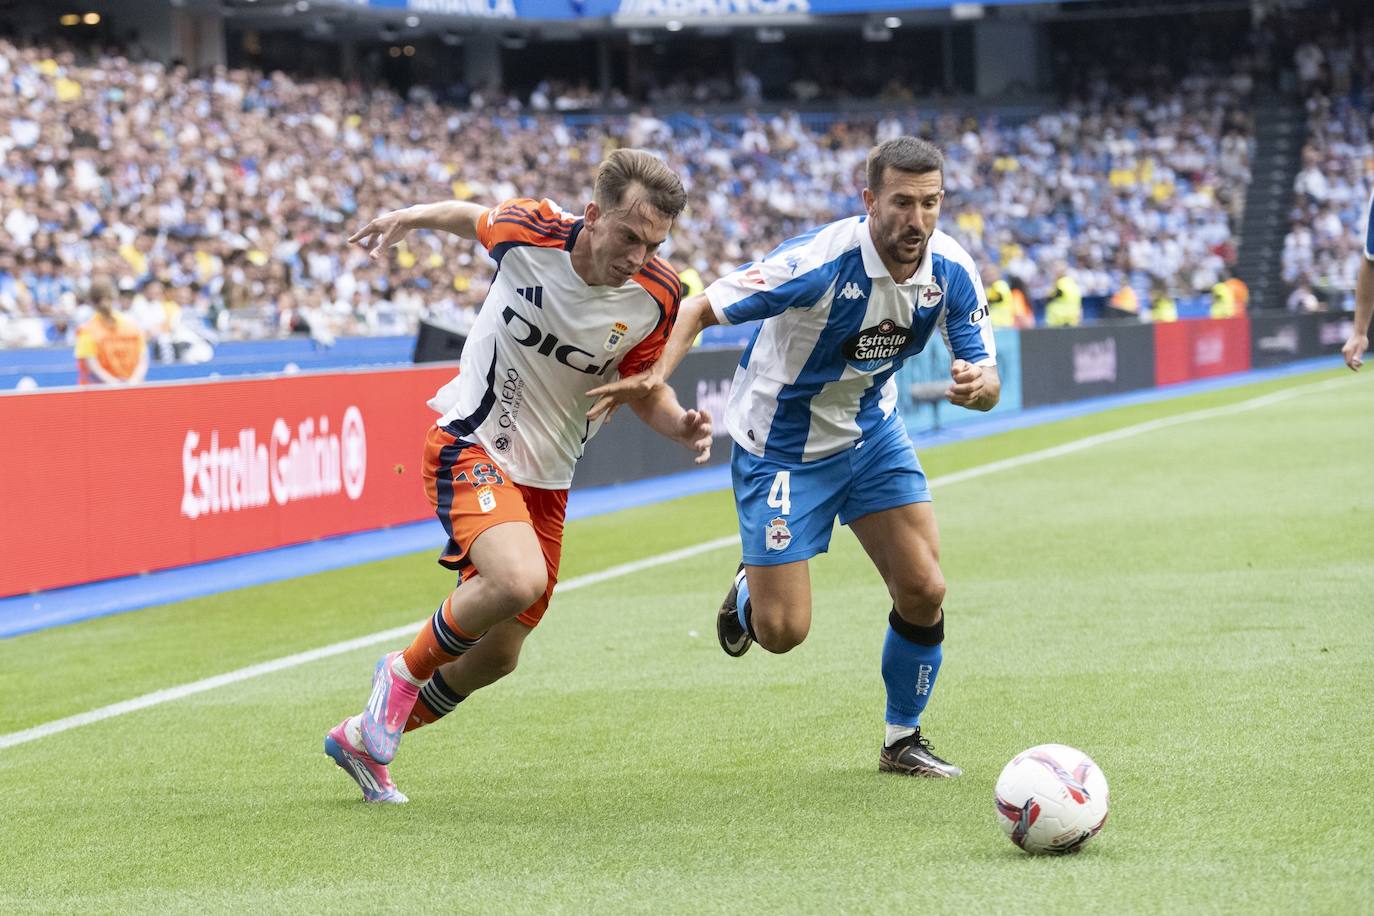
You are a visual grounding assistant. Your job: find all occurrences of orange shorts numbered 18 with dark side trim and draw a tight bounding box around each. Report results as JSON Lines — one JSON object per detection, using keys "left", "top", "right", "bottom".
{"left": 423, "top": 426, "right": 567, "bottom": 626}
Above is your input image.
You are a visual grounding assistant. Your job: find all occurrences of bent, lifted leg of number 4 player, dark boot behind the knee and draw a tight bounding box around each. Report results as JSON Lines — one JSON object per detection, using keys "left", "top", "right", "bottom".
{"left": 716, "top": 560, "right": 811, "bottom": 656}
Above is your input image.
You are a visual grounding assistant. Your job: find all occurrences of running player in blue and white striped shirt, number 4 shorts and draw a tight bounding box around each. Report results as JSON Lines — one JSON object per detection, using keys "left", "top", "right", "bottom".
{"left": 591, "top": 137, "right": 1000, "bottom": 777}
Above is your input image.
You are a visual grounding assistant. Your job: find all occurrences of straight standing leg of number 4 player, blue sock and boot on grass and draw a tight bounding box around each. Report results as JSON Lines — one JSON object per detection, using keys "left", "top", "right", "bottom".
{"left": 851, "top": 503, "right": 962, "bottom": 777}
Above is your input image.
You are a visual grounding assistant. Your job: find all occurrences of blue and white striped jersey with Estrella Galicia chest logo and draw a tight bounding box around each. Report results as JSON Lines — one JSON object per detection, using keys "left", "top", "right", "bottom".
{"left": 706, "top": 217, "right": 996, "bottom": 463}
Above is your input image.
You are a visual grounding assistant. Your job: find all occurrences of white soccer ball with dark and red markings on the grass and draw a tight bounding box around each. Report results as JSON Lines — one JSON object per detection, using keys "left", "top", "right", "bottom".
{"left": 993, "top": 744, "right": 1107, "bottom": 853}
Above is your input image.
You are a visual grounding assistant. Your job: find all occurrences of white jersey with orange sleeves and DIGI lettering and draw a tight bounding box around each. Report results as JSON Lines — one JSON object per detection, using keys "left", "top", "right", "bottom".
{"left": 429, "top": 198, "right": 682, "bottom": 489}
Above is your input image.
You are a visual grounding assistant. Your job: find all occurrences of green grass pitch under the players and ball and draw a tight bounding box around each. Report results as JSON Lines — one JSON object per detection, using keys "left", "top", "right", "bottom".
{"left": 0, "top": 369, "right": 1374, "bottom": 913}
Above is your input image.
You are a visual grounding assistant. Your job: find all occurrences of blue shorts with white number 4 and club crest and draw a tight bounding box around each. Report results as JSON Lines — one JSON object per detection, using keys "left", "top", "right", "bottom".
{"left": 730, "top": 415, "right": 930, "bottom": 566}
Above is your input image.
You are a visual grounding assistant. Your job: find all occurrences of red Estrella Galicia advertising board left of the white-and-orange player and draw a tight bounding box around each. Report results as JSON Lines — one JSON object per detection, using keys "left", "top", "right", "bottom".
{"left": 0, "top": 365, "right": 453, "bottom": 597}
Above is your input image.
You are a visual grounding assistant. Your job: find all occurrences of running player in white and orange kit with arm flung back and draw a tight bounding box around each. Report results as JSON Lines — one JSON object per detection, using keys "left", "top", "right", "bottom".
{"left": 324, "top": 150, "right": 710, "bottom": 802}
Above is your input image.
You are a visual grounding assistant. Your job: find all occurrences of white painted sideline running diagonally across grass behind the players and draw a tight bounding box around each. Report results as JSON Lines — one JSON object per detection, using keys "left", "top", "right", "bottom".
{"left": 0, "top": 378, "right": 1352, "bottom": 750}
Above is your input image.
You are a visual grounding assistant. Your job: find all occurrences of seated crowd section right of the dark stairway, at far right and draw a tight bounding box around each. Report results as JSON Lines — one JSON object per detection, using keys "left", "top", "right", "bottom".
{"left": 1283, "top": 19, "right": 1374, "bottom": 310}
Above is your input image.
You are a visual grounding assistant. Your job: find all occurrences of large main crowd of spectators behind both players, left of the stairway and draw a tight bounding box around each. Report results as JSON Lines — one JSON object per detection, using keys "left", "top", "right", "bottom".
{"left": 0, "top": 31, "right": 1250, "bottom": 352}
